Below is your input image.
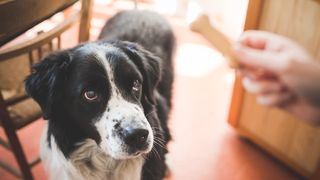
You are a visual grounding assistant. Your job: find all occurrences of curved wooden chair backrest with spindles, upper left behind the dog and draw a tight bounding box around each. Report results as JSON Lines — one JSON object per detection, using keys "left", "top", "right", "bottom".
{"left": 0, "top": 0, "right": 93, "bottom": 99}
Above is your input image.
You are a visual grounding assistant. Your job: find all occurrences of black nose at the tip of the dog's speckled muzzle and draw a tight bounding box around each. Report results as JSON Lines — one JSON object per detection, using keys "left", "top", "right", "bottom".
{"left": 123, "top": 128, "right": 149, "bottom": 150}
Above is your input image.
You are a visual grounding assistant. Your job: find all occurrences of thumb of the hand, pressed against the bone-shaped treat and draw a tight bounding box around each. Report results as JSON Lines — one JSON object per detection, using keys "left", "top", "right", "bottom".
{"left": 233, "top": 44, "right": 284, "bottom": 72}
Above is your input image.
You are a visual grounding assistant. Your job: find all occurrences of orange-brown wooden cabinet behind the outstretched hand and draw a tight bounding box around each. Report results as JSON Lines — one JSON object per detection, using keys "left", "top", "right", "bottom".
{"left": 229, "top": 0, "right": 320, "bottom": 178}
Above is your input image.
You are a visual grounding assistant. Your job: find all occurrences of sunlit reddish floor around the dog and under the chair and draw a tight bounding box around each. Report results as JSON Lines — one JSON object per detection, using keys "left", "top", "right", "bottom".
{"left": 0, "top": 0, "right": 299, "bottom": 180}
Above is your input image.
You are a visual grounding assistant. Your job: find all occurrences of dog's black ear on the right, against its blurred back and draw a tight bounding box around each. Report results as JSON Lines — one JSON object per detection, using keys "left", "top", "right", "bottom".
{"left": 120, "top": 42, "right": 162, "bottom": 105}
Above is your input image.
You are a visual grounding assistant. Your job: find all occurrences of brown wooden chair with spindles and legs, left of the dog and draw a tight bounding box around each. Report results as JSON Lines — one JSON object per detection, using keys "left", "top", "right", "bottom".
{"left": 0, "top": 0, "right": 93, "bottom": 179}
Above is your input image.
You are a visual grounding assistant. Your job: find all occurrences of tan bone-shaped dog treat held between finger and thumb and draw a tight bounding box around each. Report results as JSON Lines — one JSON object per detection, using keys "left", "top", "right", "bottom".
{"left": 190, "top": 15, "right": 239, "bottom": 68}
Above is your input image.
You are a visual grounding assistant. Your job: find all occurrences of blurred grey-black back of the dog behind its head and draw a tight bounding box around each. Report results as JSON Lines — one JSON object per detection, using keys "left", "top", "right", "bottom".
{"left": 99, "top": 11, "right": 175, "bottom": 107}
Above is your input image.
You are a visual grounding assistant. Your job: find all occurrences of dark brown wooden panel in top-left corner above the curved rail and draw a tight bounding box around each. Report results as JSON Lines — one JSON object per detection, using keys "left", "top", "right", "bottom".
{"left": 0, "top": 0, "right": 91, "bottom": 46}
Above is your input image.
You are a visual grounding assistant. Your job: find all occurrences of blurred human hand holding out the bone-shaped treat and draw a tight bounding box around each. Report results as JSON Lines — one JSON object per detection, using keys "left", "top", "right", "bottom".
{"left": 234, "top": 31, "right": 320, "bottom": 124}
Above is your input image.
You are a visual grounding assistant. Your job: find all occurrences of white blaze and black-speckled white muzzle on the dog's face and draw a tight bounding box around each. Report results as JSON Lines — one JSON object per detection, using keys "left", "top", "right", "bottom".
{"left": 80, "top": 44, "right": 153, "bottom": 158}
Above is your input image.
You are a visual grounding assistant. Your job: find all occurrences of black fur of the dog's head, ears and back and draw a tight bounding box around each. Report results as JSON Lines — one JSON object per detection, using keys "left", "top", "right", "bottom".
{"left": 25, "top": 11, "right": 175, "bottom": 180}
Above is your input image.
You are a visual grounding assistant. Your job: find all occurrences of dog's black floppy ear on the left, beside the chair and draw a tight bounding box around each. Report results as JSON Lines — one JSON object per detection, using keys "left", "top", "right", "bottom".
{"left": 25, "top": 51, "right": 71, "bottom": 119}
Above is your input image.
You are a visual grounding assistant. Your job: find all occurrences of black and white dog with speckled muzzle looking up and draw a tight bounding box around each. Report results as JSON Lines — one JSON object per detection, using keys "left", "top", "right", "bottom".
{"left": 25, "top": 11, "right": 175, "bottom": 180}
